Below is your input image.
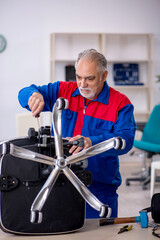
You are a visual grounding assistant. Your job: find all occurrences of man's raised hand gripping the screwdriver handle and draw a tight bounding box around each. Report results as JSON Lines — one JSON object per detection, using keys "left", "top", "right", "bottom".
{"left": 28, "top": 92, "right": 45, "bottom": 116}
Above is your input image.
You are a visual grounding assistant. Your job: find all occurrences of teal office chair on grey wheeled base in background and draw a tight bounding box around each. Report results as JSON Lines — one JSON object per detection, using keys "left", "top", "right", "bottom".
{"left": 126, "top": 105, "right": 160, "bottom": 189}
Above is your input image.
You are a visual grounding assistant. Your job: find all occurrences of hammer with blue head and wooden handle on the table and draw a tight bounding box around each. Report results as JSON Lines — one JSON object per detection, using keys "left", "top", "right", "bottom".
{"left": 99, "top": 211, "right": 148, "bottom": 228}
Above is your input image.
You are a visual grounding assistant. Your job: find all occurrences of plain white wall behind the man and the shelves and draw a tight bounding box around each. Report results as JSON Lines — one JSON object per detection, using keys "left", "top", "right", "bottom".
{"left": 0, "top": 0, "right": 160, "bottom": 140}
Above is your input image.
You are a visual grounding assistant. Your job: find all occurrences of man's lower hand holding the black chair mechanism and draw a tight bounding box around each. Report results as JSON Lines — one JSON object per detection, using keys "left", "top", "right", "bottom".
{"left": 69, "top": 135, "right": 92, "bottom": 154}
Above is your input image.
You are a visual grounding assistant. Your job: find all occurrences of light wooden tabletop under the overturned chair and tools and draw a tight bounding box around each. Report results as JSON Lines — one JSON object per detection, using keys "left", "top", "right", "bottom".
{"left": 0, "top": 219, "right": 157, "bottom": 240}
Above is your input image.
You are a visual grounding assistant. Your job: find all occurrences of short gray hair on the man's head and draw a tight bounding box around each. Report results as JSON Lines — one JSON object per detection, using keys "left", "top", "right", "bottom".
{"left": 75, "top": 49, "right": 107, "bottom": 74}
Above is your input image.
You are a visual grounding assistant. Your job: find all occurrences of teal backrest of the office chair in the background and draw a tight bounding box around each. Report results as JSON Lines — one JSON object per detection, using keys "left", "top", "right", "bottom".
{"left": 142, "top": 105, "right": 160, "bottom": 144}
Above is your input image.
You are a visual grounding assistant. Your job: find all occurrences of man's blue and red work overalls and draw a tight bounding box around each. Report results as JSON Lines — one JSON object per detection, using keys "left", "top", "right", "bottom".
{"left": 19, "top": 82, "right": 136, "bottom": 218}
